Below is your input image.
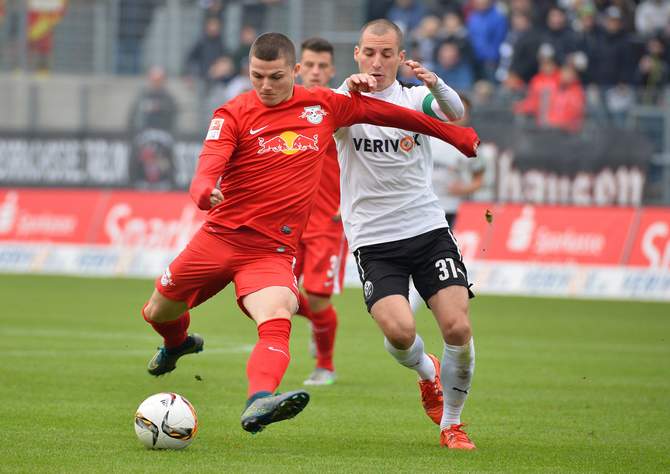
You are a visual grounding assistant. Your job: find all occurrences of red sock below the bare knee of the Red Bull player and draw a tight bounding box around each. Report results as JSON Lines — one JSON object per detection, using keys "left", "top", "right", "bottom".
{"left": 247, "top": 319, "right": 291, "bottom": 397}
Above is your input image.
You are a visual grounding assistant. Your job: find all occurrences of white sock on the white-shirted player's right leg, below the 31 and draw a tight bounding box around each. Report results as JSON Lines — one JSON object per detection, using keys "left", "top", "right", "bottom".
{"left": 440, "top": 339, "right": 475, "bottom": 429}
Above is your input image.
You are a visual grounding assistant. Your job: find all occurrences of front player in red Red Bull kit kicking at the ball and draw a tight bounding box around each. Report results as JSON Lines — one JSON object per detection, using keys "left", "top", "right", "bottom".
{"left": 142, "top": 33, "right": 479, "bottom": 433}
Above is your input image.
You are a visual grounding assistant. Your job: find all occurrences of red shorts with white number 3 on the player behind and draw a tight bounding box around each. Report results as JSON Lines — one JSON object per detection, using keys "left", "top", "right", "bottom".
{"left": 295, "top": 229, "right": 349, "bottom": 296}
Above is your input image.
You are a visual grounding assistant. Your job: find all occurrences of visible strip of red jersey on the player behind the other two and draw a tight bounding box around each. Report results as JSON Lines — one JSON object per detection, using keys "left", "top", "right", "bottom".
{"left": 302, "top": 140, "right": 344, "bottom": 239}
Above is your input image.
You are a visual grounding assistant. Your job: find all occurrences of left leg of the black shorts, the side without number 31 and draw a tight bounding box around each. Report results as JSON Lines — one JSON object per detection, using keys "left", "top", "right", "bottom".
{"left": 354, "top": 245, "right": 410, "bottom": 312}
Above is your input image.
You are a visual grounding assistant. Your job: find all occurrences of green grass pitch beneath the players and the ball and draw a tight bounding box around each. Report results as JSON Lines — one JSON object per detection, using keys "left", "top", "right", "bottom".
{"left": 0, "top": 275, "right": 670, "bottom": 473}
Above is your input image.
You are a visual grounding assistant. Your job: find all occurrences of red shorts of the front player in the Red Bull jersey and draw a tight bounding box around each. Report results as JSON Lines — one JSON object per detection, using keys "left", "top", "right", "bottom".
{"left": 156, "top": 224, "right": 298, "bottom": 312}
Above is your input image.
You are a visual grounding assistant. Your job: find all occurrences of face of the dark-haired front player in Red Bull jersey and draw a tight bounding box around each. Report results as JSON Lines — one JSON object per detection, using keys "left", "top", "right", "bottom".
{"left": 249, "top": 56, "right": 298, "bottom": 107}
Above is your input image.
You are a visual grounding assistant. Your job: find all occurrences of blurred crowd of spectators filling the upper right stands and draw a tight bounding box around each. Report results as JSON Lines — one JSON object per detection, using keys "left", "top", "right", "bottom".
{"left": 367, "top": 0, "right": 670, "bottom": 132}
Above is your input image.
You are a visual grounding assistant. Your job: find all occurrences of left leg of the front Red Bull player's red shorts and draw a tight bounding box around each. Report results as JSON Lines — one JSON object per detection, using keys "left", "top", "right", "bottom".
{"left": 155, "top": 228, "right": 236, "bottom": 308}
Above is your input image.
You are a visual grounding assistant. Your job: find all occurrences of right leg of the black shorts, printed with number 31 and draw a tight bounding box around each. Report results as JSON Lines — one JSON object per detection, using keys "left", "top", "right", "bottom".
{"left": 412, "top": 228, "right": 474, "bottom": 306}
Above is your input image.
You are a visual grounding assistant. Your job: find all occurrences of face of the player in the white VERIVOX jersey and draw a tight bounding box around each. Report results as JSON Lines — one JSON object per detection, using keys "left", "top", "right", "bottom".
{"left": 354, "top": 30, "right": 405, "bottom": 91}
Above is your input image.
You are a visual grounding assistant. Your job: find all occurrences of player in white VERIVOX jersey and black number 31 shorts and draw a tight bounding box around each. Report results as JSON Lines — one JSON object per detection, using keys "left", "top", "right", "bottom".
{"left": 335, "top": 20, "right": 475, "bottom": 449}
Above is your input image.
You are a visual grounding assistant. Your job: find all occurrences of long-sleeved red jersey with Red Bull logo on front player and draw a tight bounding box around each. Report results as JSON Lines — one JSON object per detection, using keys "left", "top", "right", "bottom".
{"left": 190, "top": 85, "right": 479, "bottom": 253}
